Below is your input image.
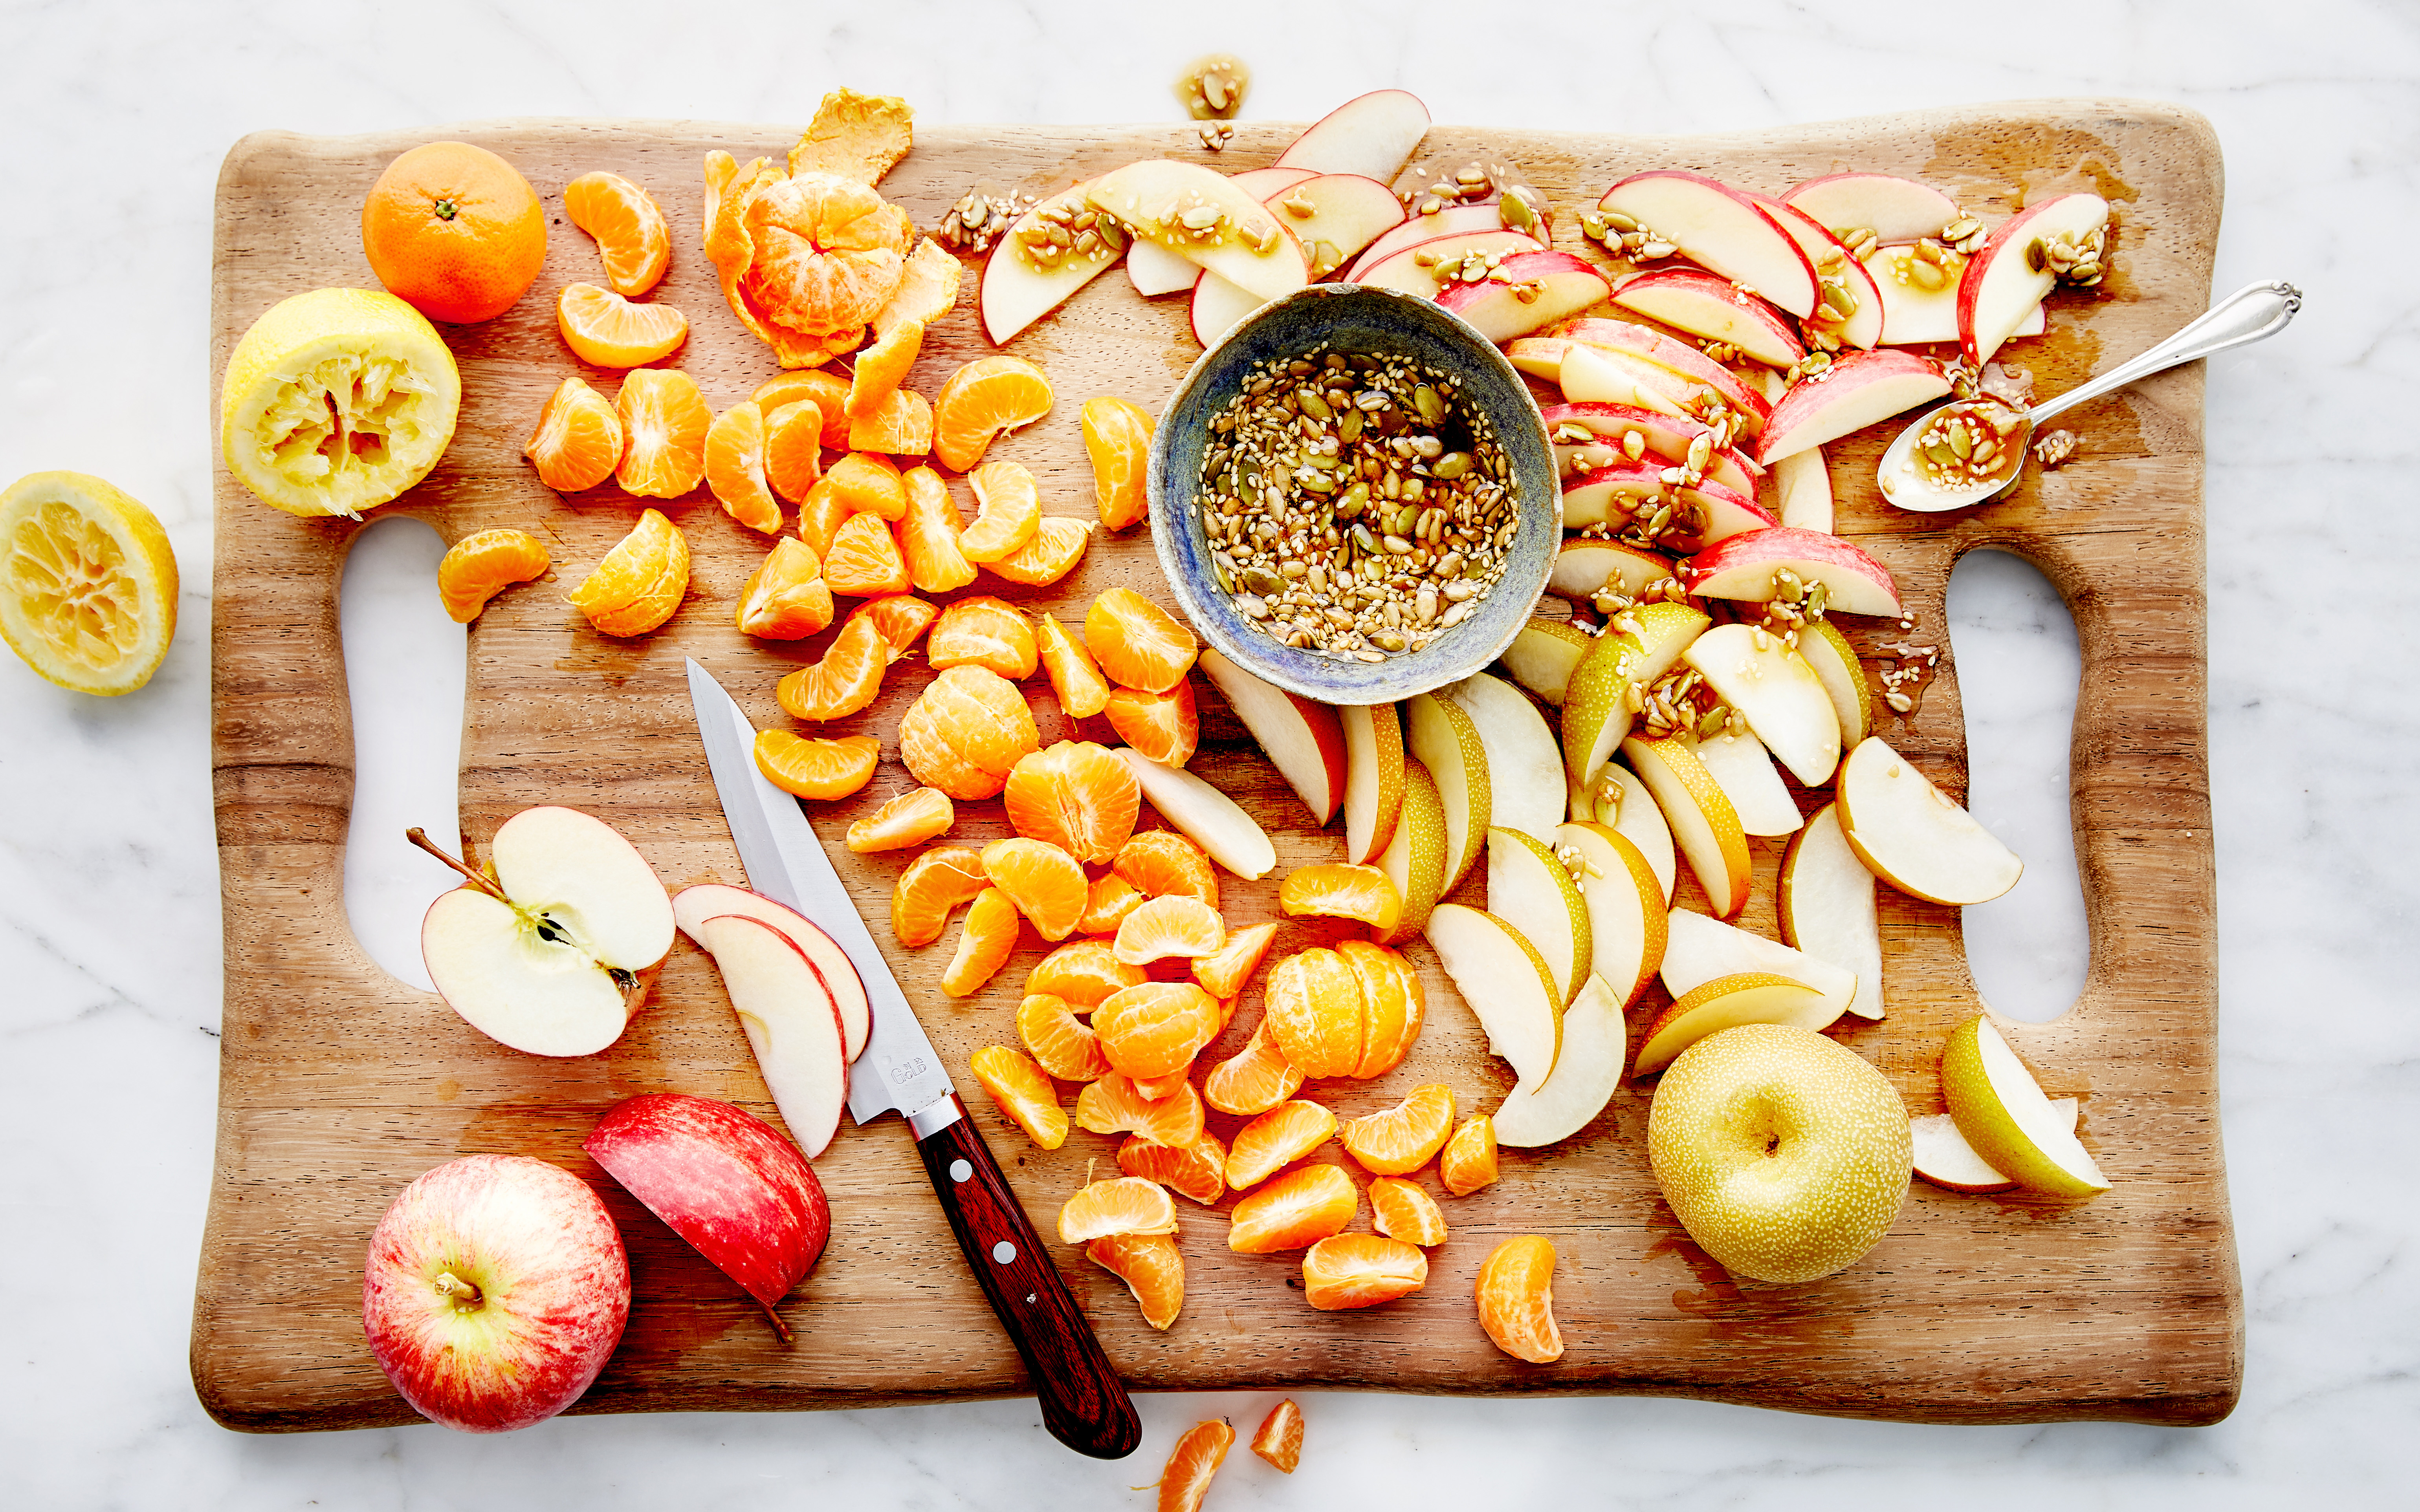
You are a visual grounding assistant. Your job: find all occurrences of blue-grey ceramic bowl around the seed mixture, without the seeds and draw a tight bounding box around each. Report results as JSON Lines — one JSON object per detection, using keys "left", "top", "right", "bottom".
{"left": 1147, "top": 283, "right": 1563, "bottom": 704}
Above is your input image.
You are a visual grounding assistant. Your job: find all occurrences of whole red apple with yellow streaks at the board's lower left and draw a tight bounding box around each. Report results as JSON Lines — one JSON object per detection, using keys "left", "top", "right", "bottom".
{"left": 361, "top": 1154, "right": 629, "bottom": 1432}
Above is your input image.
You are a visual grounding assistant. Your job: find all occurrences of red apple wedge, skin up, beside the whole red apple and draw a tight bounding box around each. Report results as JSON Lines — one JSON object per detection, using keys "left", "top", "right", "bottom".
{"left": 581, "top": 1091, "right": 832, "bottom": 1343}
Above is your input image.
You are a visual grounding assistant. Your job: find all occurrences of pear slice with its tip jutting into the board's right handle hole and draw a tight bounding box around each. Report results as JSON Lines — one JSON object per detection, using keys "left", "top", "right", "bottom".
{"left": 1832, "top": 736, "right": 2026, "bottom": 905}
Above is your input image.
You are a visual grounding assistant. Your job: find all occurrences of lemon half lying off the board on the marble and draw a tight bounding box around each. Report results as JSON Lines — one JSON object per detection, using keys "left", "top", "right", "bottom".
{"left": 0, "top": 472, "right": 177, "bottom": 694}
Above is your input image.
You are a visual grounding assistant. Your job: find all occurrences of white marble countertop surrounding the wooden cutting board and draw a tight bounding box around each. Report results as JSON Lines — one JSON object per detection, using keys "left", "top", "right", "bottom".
{"left": 0, "top": 0, "right": 2420, "bottom": 1510}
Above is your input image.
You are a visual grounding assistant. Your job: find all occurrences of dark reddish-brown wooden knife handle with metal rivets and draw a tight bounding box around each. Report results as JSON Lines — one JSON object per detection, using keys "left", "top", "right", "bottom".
{"left": 915, "top": 1093, "right": 1142, "bottom": 1459}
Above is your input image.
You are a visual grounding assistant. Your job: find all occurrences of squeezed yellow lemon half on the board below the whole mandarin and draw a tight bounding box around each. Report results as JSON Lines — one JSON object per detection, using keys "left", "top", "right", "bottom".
{"left": 218, "top": 288, "right": 462, "bottom": 518}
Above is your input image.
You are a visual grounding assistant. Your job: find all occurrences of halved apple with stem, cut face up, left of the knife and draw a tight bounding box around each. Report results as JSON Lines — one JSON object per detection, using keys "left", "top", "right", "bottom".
{"left": 414, "top": 805, "right": 673, "bottom": 1055}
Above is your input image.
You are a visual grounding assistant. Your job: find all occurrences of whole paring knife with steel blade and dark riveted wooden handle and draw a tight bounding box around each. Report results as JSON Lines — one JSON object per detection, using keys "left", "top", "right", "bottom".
{"left": 687, "top": 661, "right": 1142, "bottom": 1459}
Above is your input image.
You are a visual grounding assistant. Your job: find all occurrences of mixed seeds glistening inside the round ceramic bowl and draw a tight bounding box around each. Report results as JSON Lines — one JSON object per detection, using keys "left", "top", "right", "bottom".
{"left": 1193, "top": 346, "right": 1520, "bottom": 663}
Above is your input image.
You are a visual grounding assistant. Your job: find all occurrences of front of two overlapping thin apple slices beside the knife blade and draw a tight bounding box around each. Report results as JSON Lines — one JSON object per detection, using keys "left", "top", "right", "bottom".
{"left": 697, "top": 914, "right": 849, "bottom": 1159}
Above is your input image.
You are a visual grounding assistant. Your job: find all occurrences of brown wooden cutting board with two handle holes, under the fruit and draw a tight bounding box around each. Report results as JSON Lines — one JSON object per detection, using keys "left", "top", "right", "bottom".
{"left": 191, "top": 102, "right": 2243, "bottom": 1432}
